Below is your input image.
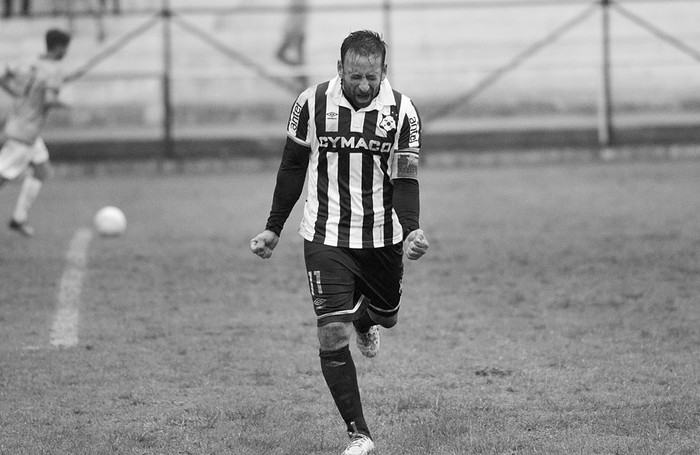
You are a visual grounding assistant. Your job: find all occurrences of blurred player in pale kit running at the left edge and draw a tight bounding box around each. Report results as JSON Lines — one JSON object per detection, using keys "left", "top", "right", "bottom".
{"left": 0, "top": 29, "right": 70, "bottom": 237}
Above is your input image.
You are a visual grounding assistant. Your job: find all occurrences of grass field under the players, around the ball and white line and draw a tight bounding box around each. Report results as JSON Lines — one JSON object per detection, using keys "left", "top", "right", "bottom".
{"left": 0, "top": 156, "right": 700, "bottom": 455}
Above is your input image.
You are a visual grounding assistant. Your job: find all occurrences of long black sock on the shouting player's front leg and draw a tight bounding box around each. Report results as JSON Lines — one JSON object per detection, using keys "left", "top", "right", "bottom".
{"left": 320, "top": 345, "right": 371, "bottom": 437}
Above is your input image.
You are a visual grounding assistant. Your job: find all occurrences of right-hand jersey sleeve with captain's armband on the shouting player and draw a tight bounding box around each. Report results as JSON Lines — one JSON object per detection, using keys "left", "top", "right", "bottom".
{"left": 391, "top": 97, "right": 421, "bottom": 179}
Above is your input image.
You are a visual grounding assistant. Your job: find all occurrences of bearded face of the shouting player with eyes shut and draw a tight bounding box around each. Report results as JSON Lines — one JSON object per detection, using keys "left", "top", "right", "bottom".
{"left": 338, "top": 52, "right": 386, "bottom": 109}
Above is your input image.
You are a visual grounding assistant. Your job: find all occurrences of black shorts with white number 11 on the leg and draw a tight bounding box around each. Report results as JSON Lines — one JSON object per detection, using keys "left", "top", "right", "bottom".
{"left": 304, "top": 240, "right": 403, "bottom": 326}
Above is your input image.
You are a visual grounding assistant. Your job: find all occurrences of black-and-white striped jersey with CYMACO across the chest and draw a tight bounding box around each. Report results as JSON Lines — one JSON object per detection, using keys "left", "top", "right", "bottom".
{"left": 287, "top": 77, "right": 421, "bottom": 248}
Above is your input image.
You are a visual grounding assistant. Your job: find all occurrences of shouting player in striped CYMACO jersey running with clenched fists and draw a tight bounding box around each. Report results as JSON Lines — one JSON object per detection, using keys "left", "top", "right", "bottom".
{"left": 250, "top": 30, "right": 429, "bottom": 455}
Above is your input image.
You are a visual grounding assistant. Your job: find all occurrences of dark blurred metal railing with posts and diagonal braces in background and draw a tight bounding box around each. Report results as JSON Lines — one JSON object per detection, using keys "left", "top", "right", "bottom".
{"left": 1, "top": 0, "right": 700, "bottom": 161}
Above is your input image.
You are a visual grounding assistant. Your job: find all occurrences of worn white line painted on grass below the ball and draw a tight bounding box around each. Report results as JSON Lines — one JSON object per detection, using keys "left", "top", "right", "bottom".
{"left": 51, "top": 228, "right": 92, "bottom": 348}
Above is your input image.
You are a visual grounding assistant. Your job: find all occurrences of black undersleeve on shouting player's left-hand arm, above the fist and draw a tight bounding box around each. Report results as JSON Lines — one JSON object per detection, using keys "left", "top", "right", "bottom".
{"left": 265, "top": 139, "right": 309, "bottom": 236}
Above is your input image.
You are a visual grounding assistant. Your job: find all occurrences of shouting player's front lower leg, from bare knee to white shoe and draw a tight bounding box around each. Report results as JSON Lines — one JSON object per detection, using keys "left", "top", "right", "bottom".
{"left": 318, "top": 322, "right": 374, "bottom": 455}
